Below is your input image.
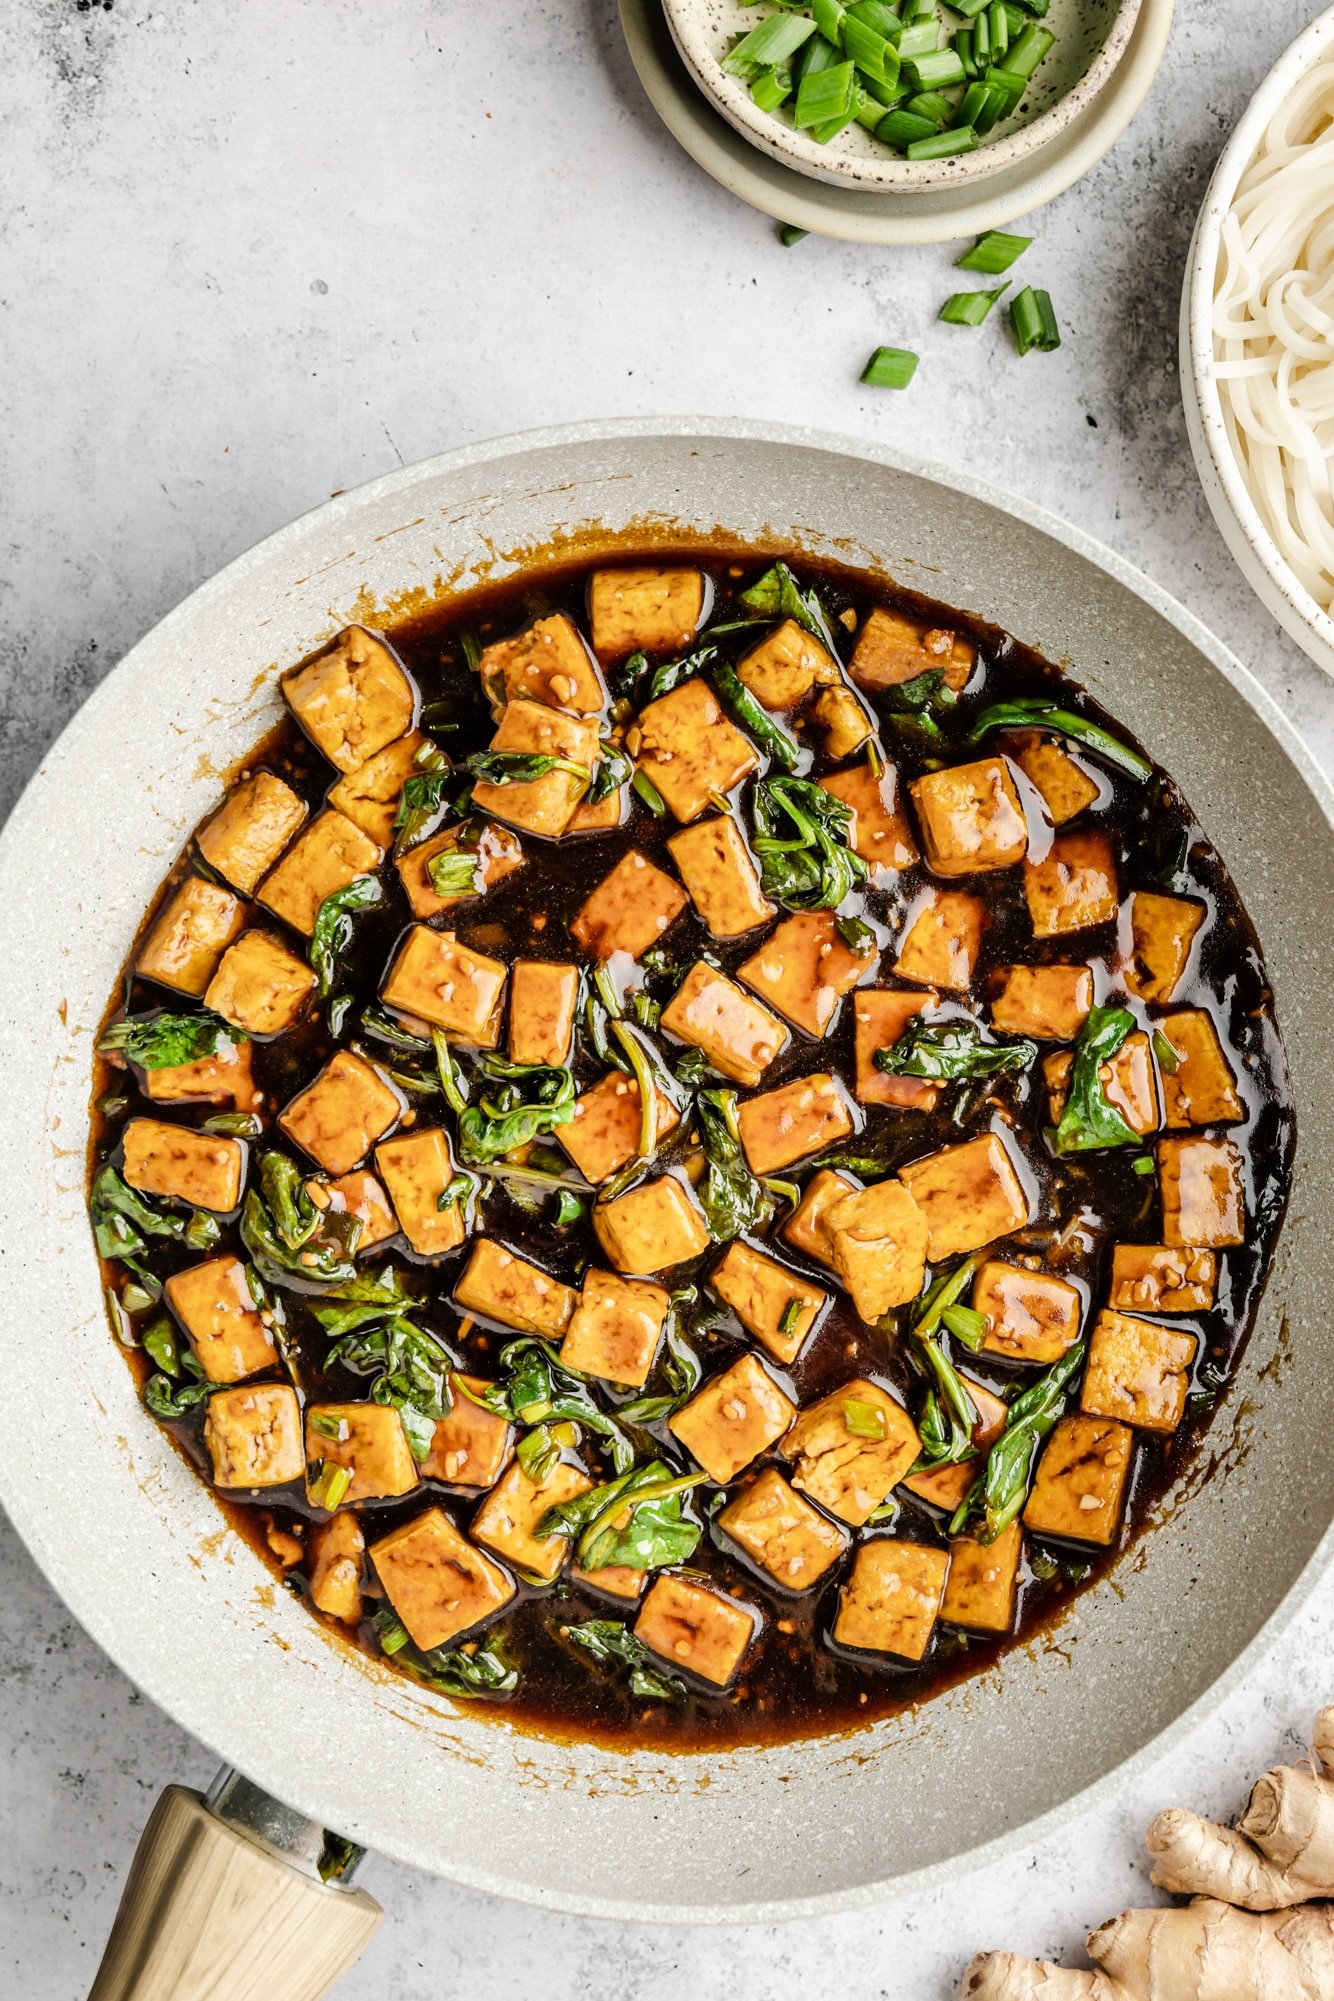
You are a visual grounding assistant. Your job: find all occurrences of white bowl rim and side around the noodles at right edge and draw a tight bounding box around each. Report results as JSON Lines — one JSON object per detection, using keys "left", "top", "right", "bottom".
{"left": 1180, "top": 8, "right": 1334, "bottom": 674}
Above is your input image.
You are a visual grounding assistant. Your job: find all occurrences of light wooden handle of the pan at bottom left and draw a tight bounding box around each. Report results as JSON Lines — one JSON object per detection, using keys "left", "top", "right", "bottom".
{"left": 88, "top": 1785, "right": 384, "bottom": 2001}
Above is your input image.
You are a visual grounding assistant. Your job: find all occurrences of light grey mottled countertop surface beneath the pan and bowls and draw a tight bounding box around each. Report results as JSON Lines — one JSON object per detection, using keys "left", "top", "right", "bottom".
{"left": 0, "top": 0, "right": 1334, "bottom": 2001}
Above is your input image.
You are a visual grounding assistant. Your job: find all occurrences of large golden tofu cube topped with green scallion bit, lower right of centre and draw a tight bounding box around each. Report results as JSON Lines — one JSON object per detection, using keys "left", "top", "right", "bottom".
{"left": 782, "top": 1377, "right": 922, "bottom": 1529}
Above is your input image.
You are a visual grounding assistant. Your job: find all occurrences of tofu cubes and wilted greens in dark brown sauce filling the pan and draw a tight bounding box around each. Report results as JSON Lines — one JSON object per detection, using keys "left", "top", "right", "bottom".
{"left": 90, "top": 550, "right": 1292, "bottom": 1747}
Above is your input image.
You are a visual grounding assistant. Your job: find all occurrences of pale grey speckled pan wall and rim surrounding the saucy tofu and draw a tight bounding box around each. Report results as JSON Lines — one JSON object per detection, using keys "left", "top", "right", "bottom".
{"left": 0, "top": 418, "right": 1334, "bottom": 1921}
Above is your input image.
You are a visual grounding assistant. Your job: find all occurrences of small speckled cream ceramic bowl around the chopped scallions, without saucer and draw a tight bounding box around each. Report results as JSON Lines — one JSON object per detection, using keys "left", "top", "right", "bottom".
{"left": 662, "top": 0, "right": 1142, "bottom": 192}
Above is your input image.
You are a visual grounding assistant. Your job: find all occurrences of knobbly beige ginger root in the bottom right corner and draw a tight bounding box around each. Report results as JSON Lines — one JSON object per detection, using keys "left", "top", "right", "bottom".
{"left": 962, "top": 1707, "right": 1334, "bottom": 2001}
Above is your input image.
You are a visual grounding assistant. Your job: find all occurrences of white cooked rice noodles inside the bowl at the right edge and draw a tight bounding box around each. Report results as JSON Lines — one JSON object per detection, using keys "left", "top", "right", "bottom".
{"left": 1212, "top": 58, "right": 1334, "bottom": 612}
